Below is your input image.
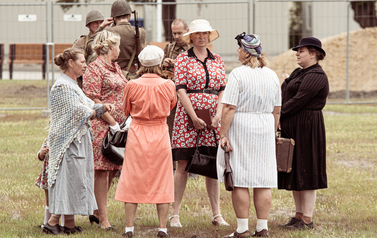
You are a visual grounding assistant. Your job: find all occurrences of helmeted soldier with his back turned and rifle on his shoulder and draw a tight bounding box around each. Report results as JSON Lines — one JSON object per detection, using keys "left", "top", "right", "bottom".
{"left": 106, "top": 0, "right": 145, "bottom": 80}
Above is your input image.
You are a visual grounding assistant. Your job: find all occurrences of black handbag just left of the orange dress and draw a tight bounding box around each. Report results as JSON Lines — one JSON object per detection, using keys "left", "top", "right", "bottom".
{"left": 102, "top": 115, "right": 129, "bottom": 165}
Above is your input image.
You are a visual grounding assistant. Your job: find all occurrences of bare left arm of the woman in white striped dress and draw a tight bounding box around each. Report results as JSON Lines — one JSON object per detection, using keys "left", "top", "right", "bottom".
{"left": 220, "top": 104, "right": 237, "bottom": 151}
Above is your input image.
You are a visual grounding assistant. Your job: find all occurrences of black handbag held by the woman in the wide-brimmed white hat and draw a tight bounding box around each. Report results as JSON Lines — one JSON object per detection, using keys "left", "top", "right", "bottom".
{"left": 185, "top": 130, "right": 217, "bottom": 179}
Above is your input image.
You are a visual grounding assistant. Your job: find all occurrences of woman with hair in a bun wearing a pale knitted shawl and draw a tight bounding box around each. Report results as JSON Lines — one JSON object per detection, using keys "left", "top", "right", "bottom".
{"left": 43, "top": 48, "right": 115, "bottom": 235}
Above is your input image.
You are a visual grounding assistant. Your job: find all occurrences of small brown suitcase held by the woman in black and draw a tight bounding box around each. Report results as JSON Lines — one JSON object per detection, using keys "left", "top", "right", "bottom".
{"left": 276, "top": 132, "right": 295, "bottom": 173}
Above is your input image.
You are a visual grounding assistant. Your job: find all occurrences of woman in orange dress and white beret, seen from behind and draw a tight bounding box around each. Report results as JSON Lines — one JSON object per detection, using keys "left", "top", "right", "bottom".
{"left": 115, "top": 46, "right": 177, "bottom": 237}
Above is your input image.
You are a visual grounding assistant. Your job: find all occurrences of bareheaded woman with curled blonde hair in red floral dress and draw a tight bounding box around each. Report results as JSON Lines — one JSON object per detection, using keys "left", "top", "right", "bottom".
{"left": 83, "top": 30, "right": 127, "bottom": 230}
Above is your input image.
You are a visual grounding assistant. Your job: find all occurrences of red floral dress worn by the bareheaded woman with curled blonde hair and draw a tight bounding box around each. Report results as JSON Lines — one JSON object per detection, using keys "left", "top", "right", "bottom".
{"left": 83, "top": 56, "right": 127, "bottom": 170}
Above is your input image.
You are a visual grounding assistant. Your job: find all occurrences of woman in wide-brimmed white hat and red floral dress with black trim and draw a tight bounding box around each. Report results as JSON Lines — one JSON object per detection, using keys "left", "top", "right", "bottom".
{"left": 169, "top": 20, "right": 229, "bottom": 227}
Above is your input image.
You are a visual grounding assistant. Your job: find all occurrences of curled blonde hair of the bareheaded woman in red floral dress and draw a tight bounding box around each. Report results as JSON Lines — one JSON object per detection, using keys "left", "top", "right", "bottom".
{"left": 92, "top": 30, "right": 120, "bottom": 55}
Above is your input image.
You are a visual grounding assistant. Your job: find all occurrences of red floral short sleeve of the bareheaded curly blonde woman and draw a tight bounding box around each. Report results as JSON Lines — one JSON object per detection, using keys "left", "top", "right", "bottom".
{"left": 82, "top": 62, "right": 103, "bottom": 101}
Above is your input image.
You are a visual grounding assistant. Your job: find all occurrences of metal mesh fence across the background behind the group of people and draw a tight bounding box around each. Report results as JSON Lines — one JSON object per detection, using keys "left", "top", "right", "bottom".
{"left": 0, "top": 0, "right": 377, "bottom": 110}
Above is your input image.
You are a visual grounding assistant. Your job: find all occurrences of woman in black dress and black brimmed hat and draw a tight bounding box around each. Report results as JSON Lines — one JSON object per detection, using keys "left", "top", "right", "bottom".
{"left": 278, "top": 37, "right": 329, "bottom": 229}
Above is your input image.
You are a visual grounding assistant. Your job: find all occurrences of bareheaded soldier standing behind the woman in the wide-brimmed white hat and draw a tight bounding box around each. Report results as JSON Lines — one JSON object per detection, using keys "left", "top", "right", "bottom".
{"left": 162, "top": 18, "right": 189, "bottom": 170}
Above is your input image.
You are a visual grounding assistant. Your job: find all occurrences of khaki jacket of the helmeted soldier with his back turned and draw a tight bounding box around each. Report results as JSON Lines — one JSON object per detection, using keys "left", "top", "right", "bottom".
{"left": 106, "top": 22, "right": 145, "bottom": 70}
